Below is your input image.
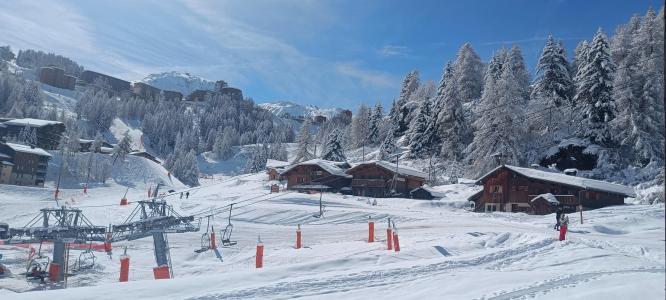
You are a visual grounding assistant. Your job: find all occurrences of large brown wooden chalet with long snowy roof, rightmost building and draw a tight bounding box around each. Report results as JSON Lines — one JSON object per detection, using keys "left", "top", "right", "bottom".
{"left": 466, "top": 165, "right": 636, "bottom": 214}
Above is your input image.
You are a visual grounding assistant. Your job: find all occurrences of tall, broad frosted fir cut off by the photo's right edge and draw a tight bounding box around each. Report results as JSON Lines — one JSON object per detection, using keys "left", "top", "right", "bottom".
{"left": 611, "top": 9, "right": 664, "bottom": 167}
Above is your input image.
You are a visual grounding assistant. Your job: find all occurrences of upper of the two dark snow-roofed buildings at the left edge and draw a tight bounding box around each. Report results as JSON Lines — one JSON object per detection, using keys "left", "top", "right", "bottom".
{"left": 0, "top": 118, "right": 65, "bottom": 150}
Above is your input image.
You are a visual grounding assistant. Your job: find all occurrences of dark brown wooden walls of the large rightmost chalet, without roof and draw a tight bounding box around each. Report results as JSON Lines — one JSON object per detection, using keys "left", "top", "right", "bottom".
{"left": 475, "top": 166, "right": 630, "bottom": 214}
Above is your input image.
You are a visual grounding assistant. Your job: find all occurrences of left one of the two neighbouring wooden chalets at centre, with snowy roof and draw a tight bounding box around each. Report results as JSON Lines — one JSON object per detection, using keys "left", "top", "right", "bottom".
{"left": 280, "top": 159, "right": 352, "bottom": 192}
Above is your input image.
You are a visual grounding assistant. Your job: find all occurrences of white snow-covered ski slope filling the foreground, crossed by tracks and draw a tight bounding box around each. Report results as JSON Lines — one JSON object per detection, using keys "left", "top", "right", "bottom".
{"left": 0, "top": 174, "right": 666, "bottom": 300}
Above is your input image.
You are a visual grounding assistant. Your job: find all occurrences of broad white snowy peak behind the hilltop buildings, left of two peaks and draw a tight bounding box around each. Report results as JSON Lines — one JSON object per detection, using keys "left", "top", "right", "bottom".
{"left": 141, "top": 71, "right": 215, "bottom": 95}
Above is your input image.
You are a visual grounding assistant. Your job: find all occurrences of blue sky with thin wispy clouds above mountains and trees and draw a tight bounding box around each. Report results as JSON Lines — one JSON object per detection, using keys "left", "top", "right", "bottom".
{"left": 0, "top": 0, "right": 662, "bottom": 108}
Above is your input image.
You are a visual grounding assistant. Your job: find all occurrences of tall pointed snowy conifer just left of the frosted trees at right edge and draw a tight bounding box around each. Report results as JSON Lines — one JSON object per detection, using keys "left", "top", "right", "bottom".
{"left": 574, "top": 29, "right": 616, "bottom": 145}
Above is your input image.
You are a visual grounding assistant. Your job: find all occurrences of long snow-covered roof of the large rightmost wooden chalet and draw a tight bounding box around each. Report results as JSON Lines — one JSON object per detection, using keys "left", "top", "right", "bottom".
{"left": 477, "top": 165, "right": 636, "bottom": 197}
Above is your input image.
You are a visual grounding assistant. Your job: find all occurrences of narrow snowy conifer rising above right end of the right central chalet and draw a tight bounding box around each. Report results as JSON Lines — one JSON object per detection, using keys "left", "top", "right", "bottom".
{"left": 409, "top": 101, "right": 435, "bottom": 158}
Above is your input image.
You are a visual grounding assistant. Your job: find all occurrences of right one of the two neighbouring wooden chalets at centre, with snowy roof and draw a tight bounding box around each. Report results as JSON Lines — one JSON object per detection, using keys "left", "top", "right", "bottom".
{"left": 347, "top": 160, "right": 428, "bottom": 198}
